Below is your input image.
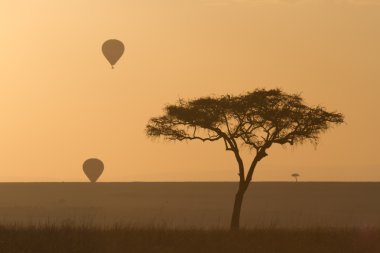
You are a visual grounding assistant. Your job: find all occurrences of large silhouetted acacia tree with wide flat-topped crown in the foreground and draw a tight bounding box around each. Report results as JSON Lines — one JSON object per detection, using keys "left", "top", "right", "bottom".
{"left": 146, "top": 89, "right": 344, "bottom": 230}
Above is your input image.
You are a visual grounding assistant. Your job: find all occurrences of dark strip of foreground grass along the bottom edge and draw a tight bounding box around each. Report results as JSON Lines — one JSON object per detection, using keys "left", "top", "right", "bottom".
{"left": 0, "top": 225, "right": 380, "bottom": 253}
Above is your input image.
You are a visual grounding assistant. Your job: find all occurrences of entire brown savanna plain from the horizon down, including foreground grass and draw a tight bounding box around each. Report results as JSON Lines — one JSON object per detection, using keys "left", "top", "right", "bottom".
{"left": 0, "top": 182, "right": 380, "bottom": 253}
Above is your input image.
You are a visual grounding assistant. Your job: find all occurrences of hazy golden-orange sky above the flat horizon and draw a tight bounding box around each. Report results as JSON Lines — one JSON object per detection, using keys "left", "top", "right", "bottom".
{"left": 0, "top": 0, "right": 380, "bottom": 181}
